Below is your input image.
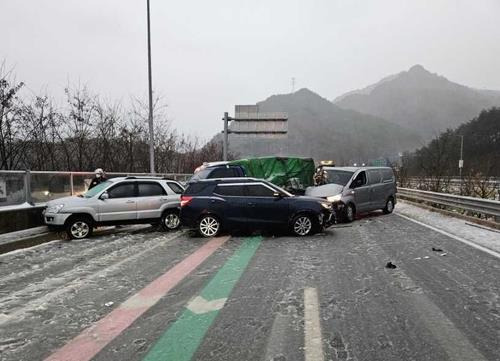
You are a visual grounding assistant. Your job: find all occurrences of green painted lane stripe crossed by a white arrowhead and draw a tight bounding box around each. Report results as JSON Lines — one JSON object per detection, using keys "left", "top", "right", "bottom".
{"left": 143, "top": 237, "right": 262, "bottom": 361}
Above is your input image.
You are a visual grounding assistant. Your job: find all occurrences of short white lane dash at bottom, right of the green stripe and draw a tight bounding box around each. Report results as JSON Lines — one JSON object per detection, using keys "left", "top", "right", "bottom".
{"left": 304, "top": 288, "right": 324, "bottom": 361}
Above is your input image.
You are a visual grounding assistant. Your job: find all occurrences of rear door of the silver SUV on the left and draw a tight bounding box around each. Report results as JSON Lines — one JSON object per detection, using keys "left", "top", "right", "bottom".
{"left": 137, "top": 181, "right": 168, "bottom": 220}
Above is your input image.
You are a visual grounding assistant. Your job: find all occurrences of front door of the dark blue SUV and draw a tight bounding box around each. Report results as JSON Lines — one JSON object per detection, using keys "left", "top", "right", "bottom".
{"left": 245, "top": 183, "right": 289, "bottom": 227}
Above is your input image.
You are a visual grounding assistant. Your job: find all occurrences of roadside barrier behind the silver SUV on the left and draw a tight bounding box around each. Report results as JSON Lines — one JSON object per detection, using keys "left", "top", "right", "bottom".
{"left": 0, "top": 170, "right": 191, "bottom": 211}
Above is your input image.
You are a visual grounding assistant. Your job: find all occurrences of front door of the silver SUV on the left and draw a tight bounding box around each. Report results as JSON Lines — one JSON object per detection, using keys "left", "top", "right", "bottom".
{"left": 98, "top": 182, "right": 137, "bottom": 222}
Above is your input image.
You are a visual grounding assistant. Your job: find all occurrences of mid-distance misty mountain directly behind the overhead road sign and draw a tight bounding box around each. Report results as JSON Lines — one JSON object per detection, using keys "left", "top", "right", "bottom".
{"left": 224, "top": 89, "right": 423, "bottom": 164}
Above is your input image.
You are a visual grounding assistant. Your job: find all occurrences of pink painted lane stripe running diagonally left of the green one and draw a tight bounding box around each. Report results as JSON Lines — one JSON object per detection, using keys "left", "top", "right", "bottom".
{"left": 45, "top": 237, "right": 229, "bottom": 361}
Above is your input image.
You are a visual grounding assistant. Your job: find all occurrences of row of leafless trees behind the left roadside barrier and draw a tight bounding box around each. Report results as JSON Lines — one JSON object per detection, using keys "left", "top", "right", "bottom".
{"left": 0, "top": 65, "right": 234, "bottom": 173}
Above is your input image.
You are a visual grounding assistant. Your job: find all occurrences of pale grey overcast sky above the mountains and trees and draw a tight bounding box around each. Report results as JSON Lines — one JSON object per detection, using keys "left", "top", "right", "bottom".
{"left": 0, "top": 0, "right": 500, "bottom": 138}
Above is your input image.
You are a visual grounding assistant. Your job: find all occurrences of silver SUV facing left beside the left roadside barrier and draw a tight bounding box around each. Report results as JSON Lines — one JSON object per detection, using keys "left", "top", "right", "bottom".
{"left": 43, "top": 177, "right": 184, "bottom": 239}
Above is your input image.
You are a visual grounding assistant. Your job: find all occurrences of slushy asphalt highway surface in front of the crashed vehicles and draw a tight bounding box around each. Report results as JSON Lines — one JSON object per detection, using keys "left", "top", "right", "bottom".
{"left": 0, "top": 210, "right": 500, "bottom": 361}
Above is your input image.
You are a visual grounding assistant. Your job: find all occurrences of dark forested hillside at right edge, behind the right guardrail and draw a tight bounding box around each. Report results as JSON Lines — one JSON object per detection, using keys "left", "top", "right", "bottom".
{"left": 403, "top": 108, "right": 500, "bottom": 177}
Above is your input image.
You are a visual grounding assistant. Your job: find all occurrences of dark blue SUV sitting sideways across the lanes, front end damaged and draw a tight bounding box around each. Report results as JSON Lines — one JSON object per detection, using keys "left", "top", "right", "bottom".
{"left": 181, "top": 178, "right": 336, "bottom": 237}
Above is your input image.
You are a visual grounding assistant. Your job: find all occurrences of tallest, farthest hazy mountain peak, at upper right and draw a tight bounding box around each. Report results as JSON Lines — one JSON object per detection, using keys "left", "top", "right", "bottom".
{"left": 334, "top": 65, "right": 500, "bottom": 141}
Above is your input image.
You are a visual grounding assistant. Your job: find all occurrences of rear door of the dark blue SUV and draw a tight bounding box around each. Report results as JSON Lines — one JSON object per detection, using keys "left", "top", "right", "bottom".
{"left": 213, "top": 183, "right": 248, "bottom": 226}
